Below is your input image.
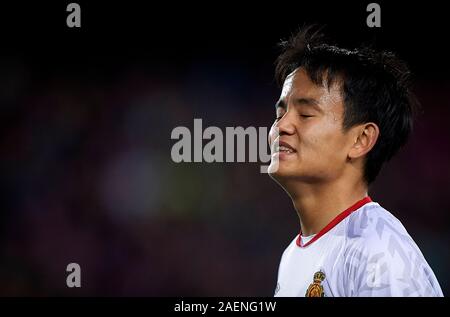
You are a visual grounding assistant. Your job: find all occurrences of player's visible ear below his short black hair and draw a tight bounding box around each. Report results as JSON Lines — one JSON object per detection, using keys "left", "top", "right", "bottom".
{"left": 348, "top": 122, "right": 380, "bottom": 160}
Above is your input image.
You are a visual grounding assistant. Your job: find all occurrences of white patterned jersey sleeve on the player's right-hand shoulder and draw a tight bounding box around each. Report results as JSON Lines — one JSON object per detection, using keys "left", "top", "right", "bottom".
{"left": 345, "top": 230, "right": 443, "bottom": 297}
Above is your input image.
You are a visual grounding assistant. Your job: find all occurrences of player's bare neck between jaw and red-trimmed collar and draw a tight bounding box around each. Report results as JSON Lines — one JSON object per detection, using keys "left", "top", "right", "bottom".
{"left": 287, "top": 177, "right": 368, "bottom": 236}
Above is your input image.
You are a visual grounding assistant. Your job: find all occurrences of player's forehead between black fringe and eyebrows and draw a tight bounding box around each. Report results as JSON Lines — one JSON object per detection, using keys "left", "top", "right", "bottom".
{"left": 280, "top": 68, "right": 342, "bottom": 103}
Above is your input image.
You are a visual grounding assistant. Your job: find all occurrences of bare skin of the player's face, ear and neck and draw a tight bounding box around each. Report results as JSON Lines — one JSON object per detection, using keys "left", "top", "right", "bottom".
{"left": 269, "top": 68, "right": 379, "bottom": 236}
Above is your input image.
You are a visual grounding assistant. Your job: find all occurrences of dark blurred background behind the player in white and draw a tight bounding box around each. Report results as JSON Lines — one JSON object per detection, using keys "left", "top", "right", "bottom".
{"left": 0, "top": 1, "right": 450, "bottom": 296}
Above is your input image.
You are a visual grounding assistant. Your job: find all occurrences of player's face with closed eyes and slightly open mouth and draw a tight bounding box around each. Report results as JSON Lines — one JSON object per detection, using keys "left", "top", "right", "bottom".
{"left": 269, "top": 68, "right": 354, "bottom": 184}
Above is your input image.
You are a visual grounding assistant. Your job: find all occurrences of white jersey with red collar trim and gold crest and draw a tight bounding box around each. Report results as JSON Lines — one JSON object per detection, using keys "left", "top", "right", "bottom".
{"left": 275, "top": 197, "right": 443, "bottom": 297}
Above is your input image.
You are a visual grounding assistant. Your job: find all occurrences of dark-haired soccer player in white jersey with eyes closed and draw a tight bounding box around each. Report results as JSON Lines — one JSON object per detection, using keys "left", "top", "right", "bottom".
{"left": 269, "top": 27, "right": 443, "bottom": 297}
